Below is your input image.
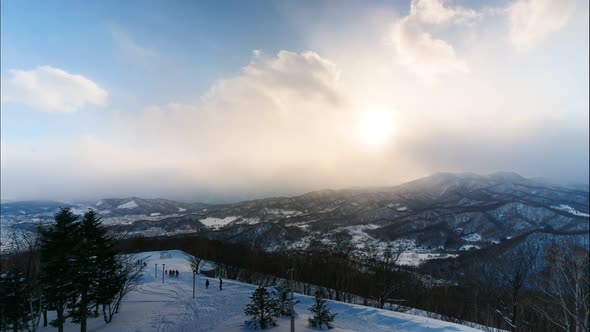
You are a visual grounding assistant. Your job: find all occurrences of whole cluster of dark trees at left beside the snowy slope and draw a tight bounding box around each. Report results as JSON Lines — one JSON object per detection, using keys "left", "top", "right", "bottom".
{"left": 0, "top": 208, "right": 144, "bottom": 332}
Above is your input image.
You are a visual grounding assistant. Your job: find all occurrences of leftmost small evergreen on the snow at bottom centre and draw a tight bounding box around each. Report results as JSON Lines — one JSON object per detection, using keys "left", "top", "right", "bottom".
{"left": 244, "top": 286, "right": 278, "bottom": 329}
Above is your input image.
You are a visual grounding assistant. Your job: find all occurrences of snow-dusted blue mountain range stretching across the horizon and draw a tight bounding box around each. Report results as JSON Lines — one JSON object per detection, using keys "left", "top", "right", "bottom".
{"left": 2, "top": 172, "right": 590, "bottom": 264}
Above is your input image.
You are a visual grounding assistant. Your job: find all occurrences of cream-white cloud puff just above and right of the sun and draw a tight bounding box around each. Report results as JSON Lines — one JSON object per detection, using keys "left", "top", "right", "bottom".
{"left": 392, "top": 16, "right": 469, "bottom": 79}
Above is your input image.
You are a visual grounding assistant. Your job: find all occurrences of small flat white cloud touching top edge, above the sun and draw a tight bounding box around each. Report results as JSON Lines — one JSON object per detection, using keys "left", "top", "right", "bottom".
{"left": 410, "top": 0, "right": 481, "bottom": 24}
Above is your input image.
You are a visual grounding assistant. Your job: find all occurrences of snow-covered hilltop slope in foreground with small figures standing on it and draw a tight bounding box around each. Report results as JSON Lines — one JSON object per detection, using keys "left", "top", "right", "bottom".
{"left": 41, "top": 250, "right": 486, "bottom": 332}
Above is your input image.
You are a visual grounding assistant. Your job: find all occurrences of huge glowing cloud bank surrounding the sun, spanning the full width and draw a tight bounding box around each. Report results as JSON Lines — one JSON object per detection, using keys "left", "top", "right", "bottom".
{"left": 0, "top": 2, "right": 588, "bottom": 200}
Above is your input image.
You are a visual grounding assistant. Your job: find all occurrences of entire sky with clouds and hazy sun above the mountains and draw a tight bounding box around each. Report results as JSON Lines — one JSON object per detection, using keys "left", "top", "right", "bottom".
{"left": 0, "top": 0, "right": 590, "bottom": 202}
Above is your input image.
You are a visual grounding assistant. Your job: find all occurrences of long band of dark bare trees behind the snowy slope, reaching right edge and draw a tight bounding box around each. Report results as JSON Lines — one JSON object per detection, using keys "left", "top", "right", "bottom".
{"left": 113, "top": 235, "right": 590, "bottom": 332}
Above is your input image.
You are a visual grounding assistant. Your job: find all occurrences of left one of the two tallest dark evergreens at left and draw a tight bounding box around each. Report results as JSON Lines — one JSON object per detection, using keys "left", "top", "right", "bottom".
{"left": 39, "top": 208, "right": 80, "bottom": 332}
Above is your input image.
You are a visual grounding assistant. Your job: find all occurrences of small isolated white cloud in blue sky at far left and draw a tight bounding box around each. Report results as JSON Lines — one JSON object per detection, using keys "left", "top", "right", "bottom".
{"left": 2, "top": 66, "right": 108, "bottom": 112}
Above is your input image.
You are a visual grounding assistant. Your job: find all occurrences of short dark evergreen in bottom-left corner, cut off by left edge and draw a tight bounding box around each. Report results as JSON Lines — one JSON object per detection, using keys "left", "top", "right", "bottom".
{"left": 0, "top": 271, "right": 30, "bottom": 332}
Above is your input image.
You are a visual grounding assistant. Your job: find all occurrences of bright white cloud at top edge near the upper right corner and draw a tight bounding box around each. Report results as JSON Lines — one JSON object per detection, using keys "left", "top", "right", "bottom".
{"left": 507, "top": 0, "right": 576, "bottom": 50}
